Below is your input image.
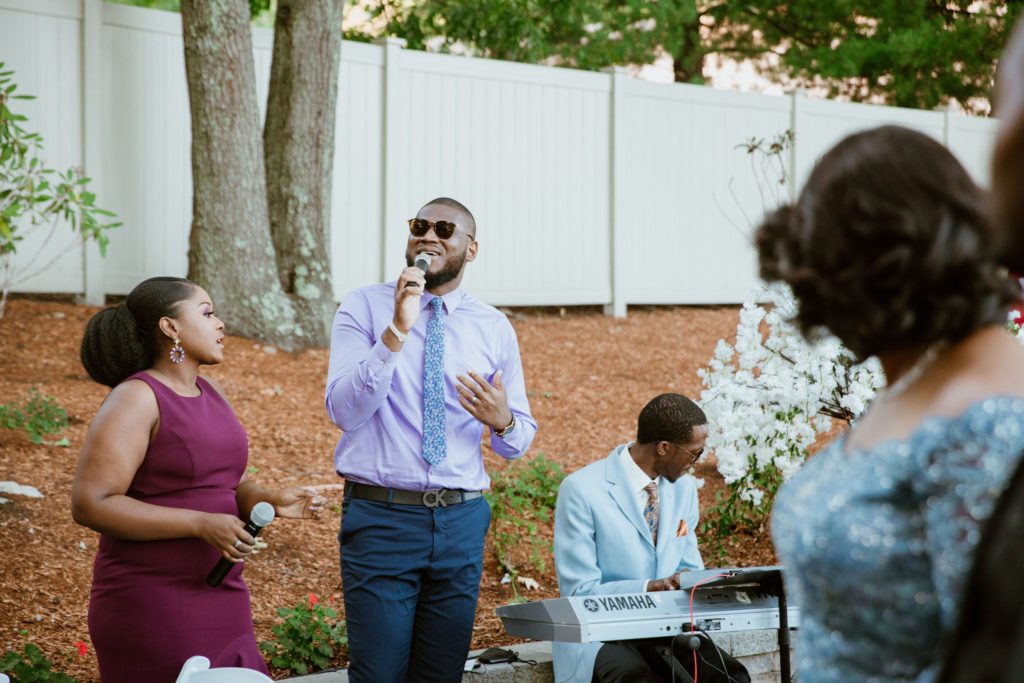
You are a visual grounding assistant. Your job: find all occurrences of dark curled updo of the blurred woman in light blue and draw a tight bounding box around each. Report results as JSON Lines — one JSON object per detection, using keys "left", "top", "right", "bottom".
{"left": 755, "top": 126, "right": 1013, "bottom": 358}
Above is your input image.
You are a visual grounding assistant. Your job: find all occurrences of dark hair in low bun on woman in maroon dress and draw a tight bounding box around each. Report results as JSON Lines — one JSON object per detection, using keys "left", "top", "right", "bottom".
{"left": 80, "top": 278, "right": 196, "bottom": 387}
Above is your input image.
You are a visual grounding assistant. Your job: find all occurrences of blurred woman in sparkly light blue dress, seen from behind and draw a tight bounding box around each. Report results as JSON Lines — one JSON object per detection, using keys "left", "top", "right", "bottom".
{"left": 757, "top": 126, "right": 1024, "bottom": 683}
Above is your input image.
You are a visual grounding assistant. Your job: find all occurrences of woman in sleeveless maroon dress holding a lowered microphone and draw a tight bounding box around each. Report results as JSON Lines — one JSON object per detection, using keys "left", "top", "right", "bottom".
{"left": 72, "top": 278, "right": 333, "bottom": 683}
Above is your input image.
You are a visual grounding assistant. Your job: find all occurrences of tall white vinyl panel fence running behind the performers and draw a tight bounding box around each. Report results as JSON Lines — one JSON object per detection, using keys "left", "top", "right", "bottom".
{"left": 0, "top": 0, "right": 995, "bottom": 314}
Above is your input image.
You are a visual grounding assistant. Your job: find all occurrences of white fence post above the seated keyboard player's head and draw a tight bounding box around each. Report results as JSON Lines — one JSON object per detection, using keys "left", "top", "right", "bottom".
{"left": 601, "top": 67, "right": 629, "bottom": 317}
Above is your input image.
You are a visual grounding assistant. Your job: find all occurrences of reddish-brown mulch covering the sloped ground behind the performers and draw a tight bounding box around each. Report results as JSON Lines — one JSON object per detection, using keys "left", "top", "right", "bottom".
{"left": 0, "top": 298, "right": 776, "bottom": 681}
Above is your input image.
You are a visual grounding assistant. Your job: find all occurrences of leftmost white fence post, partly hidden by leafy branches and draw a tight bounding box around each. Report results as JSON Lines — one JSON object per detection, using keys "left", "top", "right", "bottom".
{"left": 81, "top": 0, "right": 106, "bottom": 306}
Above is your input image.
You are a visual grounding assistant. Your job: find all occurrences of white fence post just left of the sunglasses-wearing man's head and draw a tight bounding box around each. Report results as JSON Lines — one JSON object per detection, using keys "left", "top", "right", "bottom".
{"left": 374, "top": 37, "right": 406, "bottom": 282}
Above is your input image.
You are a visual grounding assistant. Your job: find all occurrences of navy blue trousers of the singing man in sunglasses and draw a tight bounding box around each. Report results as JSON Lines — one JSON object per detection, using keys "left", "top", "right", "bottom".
{"left": 338, "top": 498, "right": 490, "bottom": 683}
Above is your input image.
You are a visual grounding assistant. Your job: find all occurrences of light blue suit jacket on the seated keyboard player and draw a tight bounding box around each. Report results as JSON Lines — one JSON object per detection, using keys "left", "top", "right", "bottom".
{"left": 552, "top": 443, "right": 703, "bottom": 683}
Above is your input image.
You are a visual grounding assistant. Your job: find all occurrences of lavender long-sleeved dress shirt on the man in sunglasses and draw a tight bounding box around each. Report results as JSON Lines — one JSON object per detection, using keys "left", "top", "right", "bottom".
{"left": 325, "top": 282, "right": 537, "bottom": 490}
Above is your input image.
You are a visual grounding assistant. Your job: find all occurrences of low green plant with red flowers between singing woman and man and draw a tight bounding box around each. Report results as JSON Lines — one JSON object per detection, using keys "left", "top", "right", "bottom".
{"left": 259, "top": 593, "right": 348, "bottom": 676}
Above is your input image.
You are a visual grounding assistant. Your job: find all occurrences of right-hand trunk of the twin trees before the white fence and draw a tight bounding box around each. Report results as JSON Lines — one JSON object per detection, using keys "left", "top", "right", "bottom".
{"left": 263, "top": 0, "right": 344, "bottom": 346}
